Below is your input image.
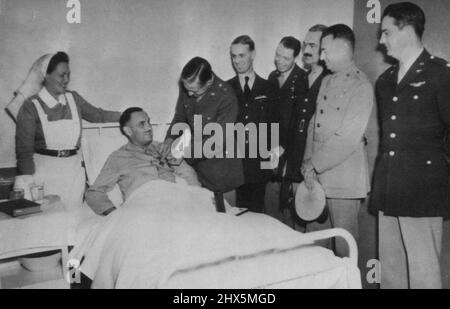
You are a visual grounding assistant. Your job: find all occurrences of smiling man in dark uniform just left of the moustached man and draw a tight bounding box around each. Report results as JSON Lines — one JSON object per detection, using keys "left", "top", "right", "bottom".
{"left": 268, "top": 37, "right": 310, "bottom": 223}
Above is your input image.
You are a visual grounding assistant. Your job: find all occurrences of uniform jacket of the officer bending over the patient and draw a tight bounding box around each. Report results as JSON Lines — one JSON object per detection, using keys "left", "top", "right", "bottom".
{"left": 167, "top": 76, "right": 244, "bottom": 192}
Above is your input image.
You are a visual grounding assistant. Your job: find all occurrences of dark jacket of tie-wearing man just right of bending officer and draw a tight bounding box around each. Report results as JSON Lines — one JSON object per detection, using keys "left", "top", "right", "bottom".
{"left": 228, "top": 75, "right": 279, "bottom": 183}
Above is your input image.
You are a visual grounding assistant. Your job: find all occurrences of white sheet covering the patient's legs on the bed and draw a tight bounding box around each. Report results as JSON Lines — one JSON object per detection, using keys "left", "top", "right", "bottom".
{"left": 67, "top": 181, "right": 361, "bottom": 288}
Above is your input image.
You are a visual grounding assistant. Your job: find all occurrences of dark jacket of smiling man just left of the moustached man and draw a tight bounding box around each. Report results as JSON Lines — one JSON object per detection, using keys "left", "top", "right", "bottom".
{"left": 268, "top": 65, "right": 308, "bottom": 150}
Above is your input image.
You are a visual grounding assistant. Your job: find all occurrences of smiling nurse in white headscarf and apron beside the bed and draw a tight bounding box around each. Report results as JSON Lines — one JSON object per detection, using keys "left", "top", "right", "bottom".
{"left": 15, "top": 52, "right": 120, "bottom": 209}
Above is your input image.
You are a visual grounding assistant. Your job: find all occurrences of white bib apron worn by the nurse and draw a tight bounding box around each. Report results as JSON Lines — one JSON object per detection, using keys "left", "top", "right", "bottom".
{"left": 33, "top": 93, "right": 86, "bottom": 210}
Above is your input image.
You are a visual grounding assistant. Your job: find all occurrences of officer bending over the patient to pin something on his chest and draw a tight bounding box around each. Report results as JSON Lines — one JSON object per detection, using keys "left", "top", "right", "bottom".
{"left": 160, "top": 57, "right": 244, "bottom": 202}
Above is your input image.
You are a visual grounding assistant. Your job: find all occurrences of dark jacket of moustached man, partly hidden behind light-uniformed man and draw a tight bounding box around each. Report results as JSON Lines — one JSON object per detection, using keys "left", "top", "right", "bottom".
{"left": 285, "top": 70, "right": 329, "bottom": 182}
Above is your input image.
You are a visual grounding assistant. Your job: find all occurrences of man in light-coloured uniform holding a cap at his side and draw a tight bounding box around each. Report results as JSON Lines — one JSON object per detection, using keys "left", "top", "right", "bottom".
{"left": 302, "top": 24, "right": 374, "bottom": 256}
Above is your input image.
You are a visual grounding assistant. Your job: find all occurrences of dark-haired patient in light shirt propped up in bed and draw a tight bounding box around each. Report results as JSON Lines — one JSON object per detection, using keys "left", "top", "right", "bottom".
{"left": 85, "top": 108, "right": 200, "bottom": 215}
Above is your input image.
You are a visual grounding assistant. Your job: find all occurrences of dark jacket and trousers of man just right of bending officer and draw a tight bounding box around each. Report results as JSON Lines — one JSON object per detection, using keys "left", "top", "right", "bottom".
{"left": 228, "top": 75, "right": 279, "bottom": 213}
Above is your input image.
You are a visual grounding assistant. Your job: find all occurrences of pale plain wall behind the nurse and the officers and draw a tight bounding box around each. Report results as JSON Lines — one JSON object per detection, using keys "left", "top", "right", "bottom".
{"left": 0, "top": 0, "right": 353, "bottom": 167}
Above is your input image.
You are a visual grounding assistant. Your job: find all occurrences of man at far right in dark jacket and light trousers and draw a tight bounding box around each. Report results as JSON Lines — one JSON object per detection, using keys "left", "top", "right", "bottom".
{"left": 371, "top": 2, "right": 450, "bottom": 288}
